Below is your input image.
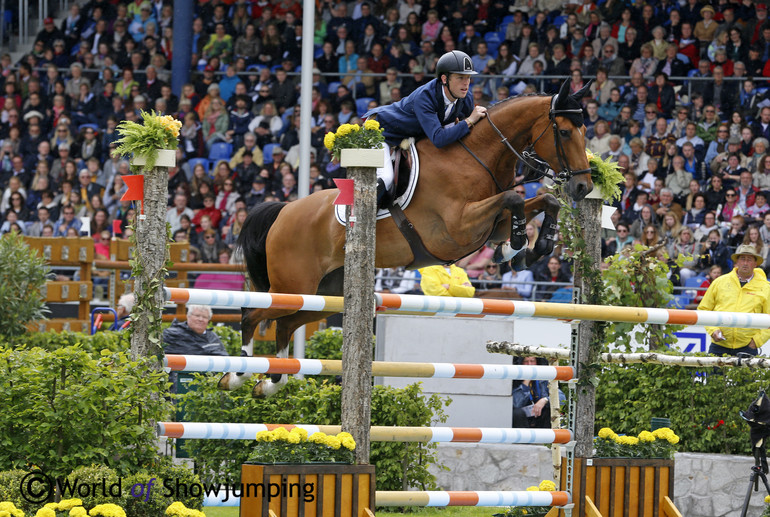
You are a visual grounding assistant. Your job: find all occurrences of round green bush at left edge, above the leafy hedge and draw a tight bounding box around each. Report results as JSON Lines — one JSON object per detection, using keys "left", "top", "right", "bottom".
{"left": 0, "top": 232, "right": 50, "bottom": 337}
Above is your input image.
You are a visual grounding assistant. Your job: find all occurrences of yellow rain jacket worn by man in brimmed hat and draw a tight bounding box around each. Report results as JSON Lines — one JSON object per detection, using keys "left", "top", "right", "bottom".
{"left": 698, "top": 268, "right": 770, "bottom": 348}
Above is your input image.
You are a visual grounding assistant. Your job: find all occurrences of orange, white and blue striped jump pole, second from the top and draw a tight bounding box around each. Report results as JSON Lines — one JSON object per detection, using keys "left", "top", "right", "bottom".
{"left": 163, "top": 355, "right": 575, "bottom": 381}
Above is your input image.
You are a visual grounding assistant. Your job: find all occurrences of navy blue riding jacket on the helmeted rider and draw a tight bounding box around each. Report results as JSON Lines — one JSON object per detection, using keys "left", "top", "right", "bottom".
{"left": 364, "top": 79, "right": 474, "bottom": 148}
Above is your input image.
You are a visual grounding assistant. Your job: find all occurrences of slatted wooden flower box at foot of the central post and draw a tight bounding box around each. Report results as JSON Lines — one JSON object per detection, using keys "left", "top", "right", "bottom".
{"left": 240, "top": 463, "right": 375, "bottom": 517}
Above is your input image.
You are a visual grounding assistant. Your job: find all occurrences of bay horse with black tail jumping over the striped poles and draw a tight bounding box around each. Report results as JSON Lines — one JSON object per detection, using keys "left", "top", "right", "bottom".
{"left": 219, "top": 81, "right": 593, "bottom": 396}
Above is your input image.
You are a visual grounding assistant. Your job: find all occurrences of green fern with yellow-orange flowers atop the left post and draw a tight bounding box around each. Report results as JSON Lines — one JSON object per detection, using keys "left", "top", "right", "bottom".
{"left": 117, "top": 110, "right": 182, "bottom": 171}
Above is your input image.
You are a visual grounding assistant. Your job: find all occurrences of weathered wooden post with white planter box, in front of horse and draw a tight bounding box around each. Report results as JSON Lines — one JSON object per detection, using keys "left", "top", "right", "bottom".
{"left": 340, "top": 149, "right": 385, "bottom": 465}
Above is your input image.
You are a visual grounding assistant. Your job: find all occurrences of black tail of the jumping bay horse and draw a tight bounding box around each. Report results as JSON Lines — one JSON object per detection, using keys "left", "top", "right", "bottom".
{"left": 237, "top": 202, "right": 286, "bottom": 292}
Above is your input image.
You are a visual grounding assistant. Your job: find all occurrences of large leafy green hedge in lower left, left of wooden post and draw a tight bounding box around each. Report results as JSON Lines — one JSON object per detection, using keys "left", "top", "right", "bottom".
{"left": 0, "top": 346, "right": 170, "bottom": 477}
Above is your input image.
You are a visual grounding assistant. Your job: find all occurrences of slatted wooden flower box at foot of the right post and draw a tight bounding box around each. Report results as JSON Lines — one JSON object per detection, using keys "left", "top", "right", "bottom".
{"left": 559, "top": 458, "right": 674, "bottom": 517}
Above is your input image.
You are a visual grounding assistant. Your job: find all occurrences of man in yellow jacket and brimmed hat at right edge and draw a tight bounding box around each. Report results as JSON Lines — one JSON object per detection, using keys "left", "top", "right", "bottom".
{"left": 698, "top": 244, "right": 770, "bottom": 355}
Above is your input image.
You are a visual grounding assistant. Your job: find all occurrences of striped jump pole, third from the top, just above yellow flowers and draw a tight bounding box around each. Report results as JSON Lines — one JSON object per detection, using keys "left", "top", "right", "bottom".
{"left": 157, "top": 422, "right": 573, "bottom": 444}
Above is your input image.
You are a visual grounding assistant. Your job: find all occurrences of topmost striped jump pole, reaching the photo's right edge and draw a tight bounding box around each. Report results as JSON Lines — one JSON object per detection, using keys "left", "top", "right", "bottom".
{"left": 164, "top": 288, "right": 770, "bottom": 329}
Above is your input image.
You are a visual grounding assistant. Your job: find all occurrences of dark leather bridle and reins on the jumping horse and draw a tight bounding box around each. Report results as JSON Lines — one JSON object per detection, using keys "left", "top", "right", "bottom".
{"left": 460, "top": 94, "right": 591, "bottom": 192}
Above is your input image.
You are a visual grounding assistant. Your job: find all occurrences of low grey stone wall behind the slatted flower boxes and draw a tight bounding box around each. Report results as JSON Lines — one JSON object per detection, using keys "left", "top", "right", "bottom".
{"left": 430, "top": 443, "right": 767, "bottom": 517}
